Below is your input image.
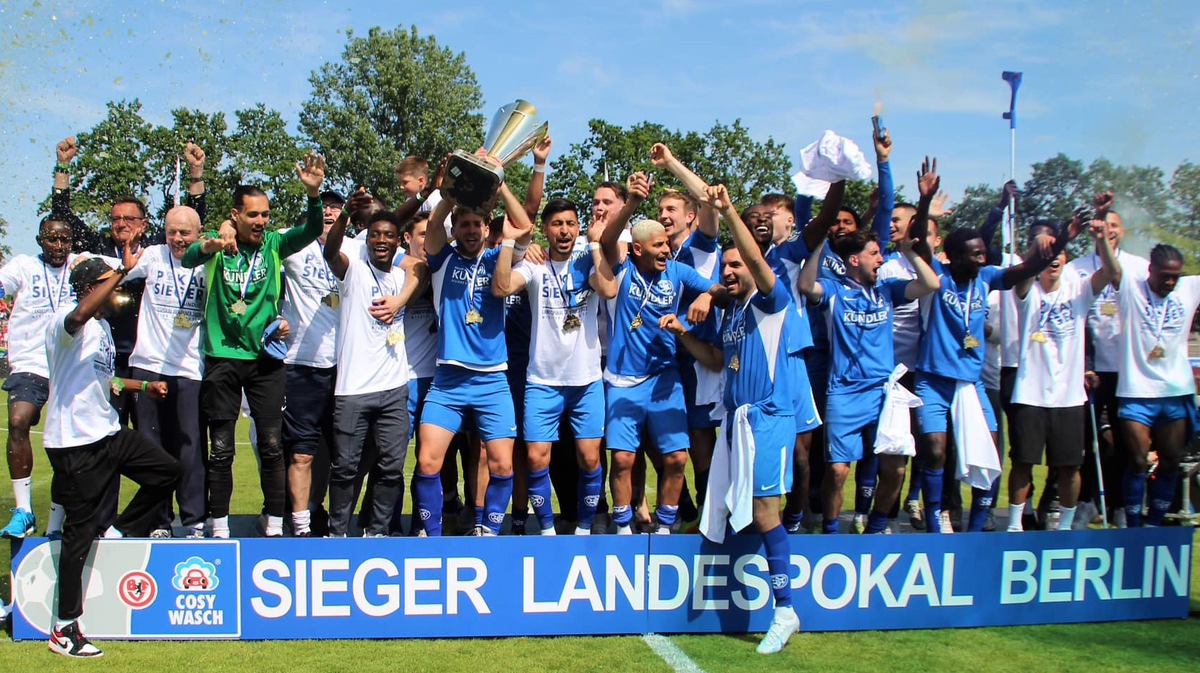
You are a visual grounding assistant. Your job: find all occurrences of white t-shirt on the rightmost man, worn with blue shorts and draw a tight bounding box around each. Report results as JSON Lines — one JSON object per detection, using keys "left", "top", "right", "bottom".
{"left": 1117, "top": 272, "right": 1200, "bottom": 398}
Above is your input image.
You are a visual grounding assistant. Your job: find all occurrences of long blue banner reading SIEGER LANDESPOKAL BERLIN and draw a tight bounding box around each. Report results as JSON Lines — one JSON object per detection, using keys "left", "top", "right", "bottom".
{"left": 12, "top": 528, "right": 1193, "bottom": 639}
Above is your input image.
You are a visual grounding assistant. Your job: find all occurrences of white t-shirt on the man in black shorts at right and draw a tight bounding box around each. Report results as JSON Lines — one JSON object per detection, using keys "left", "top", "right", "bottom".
{"left": 1013, "top": 275, "right": 1096, "bottom": 408}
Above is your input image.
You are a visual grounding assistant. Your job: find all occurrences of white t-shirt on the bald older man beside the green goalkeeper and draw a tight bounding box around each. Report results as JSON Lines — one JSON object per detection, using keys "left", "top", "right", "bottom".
{"left": 125, "top": 245, "right": 208, "bottom": 380}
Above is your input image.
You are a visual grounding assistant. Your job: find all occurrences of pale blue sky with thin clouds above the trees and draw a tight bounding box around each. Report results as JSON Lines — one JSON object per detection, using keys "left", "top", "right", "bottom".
{"left": 0, "top": 0, "right": 1200, "bottom": 252}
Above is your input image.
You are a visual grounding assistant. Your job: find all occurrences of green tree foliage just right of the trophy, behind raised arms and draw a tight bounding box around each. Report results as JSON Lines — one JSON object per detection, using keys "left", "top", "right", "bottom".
{"left": 546, "top": 119, "right": 794, "bottom": 223}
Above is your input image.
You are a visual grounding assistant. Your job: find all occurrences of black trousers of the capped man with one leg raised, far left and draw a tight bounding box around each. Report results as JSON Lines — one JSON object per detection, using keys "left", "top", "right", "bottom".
{"left": 46, "top": 427, "right": 181, "bottom": 620}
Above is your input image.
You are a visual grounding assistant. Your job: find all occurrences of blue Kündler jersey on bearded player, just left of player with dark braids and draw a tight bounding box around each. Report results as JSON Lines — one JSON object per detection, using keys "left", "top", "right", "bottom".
{"left": 817, "top": 278, "right": 908, "bottom": 395}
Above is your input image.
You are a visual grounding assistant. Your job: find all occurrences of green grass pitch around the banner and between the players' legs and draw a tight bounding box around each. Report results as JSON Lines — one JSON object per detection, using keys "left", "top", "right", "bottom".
{"left": 0, "top": 415, "right": 1200, "bottom": 673}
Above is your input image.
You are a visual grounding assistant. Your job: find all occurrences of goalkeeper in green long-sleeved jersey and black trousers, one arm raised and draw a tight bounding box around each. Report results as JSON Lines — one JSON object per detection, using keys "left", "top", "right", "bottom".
{"left": 180, "top": 154, "right": 325, "bottom": 537}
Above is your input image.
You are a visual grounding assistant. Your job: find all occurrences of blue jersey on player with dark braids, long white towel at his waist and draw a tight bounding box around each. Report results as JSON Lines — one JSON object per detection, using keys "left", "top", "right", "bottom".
{"left": 917, "top": 260, "right": 1006, "bottom": 381}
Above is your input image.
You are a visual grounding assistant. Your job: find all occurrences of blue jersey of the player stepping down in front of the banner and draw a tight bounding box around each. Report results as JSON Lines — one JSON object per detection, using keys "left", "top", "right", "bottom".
{"left": 721, "top": 282, "right": 800, "bottom": 416}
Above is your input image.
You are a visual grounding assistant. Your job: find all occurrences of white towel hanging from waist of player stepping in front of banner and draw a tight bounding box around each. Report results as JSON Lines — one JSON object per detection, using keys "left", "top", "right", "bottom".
{"left": 700, "top": 404, "right": 755, "bottom": 545}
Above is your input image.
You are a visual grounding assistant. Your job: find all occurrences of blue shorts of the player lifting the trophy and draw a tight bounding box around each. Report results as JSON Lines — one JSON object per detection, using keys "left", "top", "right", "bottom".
{"left": 421, "top": 365, "right": 517, "bottom": 441}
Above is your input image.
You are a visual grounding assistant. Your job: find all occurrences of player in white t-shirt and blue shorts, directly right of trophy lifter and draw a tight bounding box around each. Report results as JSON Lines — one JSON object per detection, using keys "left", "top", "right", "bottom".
{"left": 492, "top": 199, "right": 617, "bottom": 535}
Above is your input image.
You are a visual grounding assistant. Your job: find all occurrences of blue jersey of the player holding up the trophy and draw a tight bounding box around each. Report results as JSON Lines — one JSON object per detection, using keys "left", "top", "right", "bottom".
{"left": 427, "top": 245, "right": 508, "bottom": 372}
